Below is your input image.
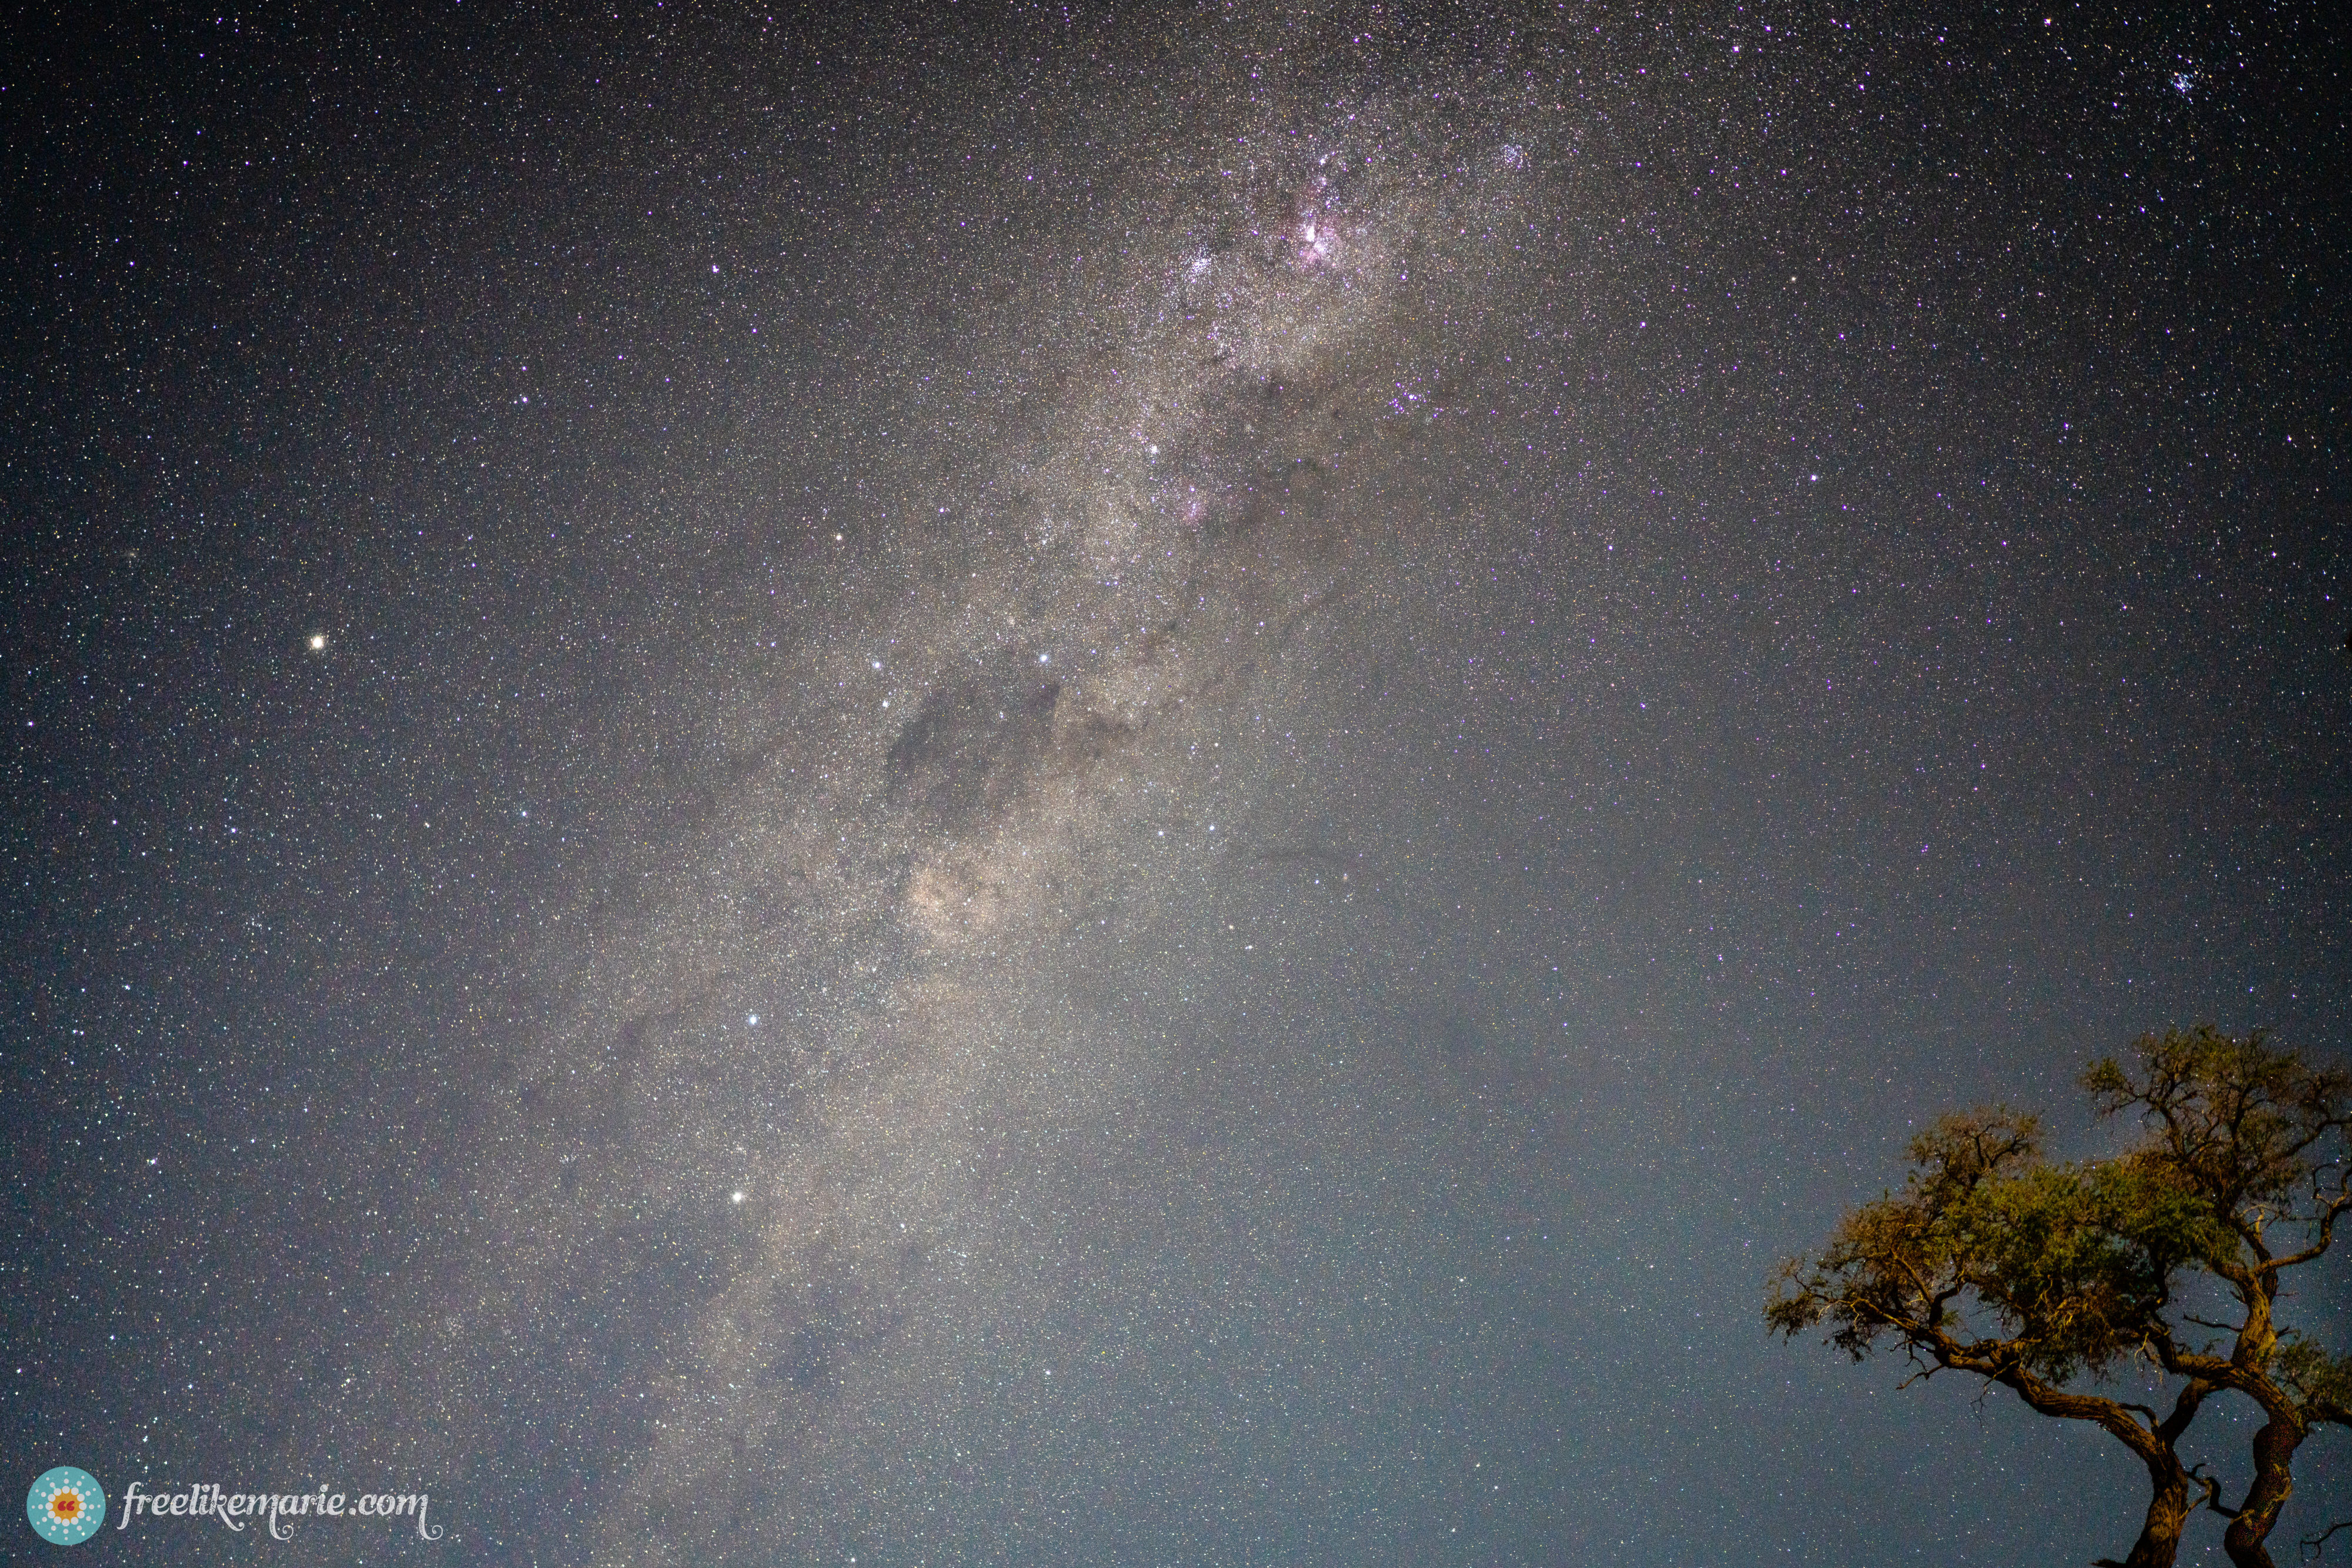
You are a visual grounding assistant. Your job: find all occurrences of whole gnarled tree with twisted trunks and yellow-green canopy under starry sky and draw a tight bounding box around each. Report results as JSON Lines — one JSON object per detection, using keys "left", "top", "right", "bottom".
{"left": 1764, "top": 1027, "right": 2352, "bottom": 1568}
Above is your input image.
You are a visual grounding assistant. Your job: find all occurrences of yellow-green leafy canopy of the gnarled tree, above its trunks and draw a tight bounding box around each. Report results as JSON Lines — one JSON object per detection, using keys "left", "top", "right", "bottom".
{"left": 1766, "top": 1025, "right": 2352, "bottom": 1382}
